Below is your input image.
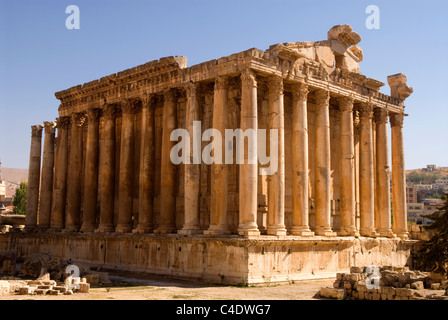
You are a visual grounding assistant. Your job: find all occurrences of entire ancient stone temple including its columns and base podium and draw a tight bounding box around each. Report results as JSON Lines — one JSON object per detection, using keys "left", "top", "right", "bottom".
{"left": 9, "top": 25, "right": 412, "bottom": 283}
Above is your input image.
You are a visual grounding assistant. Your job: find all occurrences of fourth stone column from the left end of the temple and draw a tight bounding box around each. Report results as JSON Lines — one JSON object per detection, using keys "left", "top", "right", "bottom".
{"left": 64, "top": 113, "right": 85, "bottom": 232}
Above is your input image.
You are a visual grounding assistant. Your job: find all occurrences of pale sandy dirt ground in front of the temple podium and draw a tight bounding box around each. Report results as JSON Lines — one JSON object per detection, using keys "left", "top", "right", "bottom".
{"left": 0, "top": 275, "right": 334, "bottom": 300}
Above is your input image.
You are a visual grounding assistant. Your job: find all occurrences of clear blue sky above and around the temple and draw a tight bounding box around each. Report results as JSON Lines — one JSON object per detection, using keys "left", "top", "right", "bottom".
{"left": 0, "top": 0, "right": 448, "bottom": 169}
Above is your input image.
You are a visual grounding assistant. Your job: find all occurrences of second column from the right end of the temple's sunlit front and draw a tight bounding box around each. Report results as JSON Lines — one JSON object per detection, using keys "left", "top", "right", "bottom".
{"left": 374, "top": 108, "right": 395, "bottom": 238}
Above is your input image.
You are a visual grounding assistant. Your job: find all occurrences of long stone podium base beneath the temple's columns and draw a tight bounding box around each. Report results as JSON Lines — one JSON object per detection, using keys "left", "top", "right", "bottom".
{"left": 0, "top": 233, "right": 415, "bottom": 285}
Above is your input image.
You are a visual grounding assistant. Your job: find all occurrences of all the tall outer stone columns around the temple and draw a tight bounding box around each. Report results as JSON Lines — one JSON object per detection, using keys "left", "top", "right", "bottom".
{"left": 26, "top": 69, "right": 407, "bottom": 237}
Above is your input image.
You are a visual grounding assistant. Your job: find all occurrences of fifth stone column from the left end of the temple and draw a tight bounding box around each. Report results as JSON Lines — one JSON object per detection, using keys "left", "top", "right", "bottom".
{"left": 81, "top": 108, "right": 101, "bottom": 232}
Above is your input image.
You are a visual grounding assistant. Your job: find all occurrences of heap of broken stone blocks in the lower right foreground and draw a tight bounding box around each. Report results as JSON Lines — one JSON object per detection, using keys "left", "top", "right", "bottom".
{"left": 320, "top": 266, "right": 448, "bottom": 300}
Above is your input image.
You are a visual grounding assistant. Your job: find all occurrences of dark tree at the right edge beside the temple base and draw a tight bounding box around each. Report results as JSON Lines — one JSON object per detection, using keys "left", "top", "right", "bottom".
{"left": 413, "top": 196, "right": 448, "bottom": 276}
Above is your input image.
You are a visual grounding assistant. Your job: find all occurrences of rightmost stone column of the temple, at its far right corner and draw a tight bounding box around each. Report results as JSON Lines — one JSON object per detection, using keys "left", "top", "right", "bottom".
{"left": 390, "top": 113, "right": 409, "bottom": 239}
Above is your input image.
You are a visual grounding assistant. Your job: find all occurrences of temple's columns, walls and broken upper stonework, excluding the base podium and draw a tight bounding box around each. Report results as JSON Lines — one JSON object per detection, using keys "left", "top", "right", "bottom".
{"left": 17, "top": 25, "right": 412, "bottom": 284}
